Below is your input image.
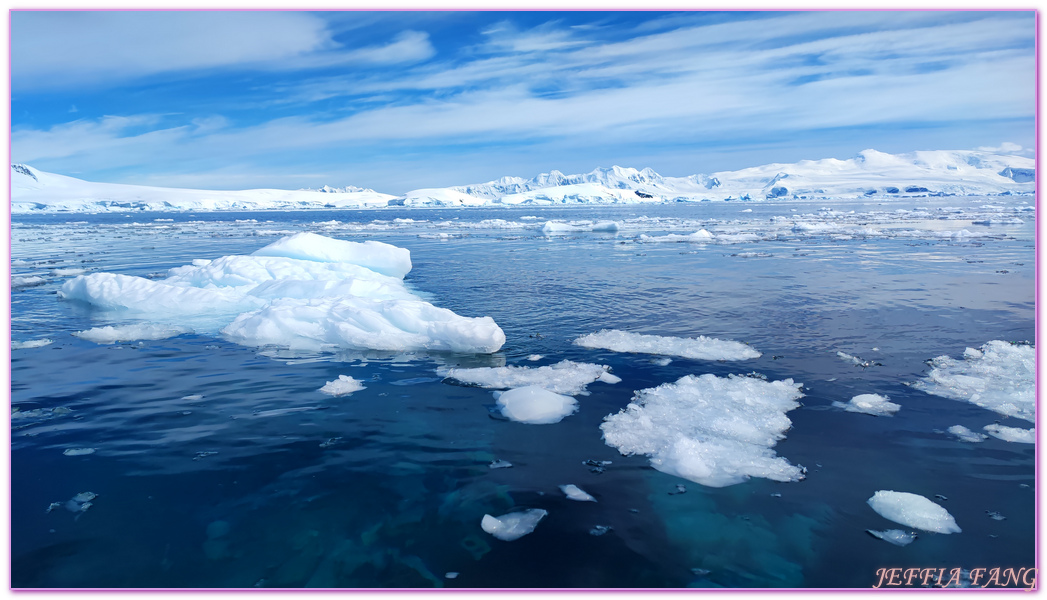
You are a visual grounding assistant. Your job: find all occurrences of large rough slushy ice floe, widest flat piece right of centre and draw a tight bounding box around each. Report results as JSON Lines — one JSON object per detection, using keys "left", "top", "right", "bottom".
{"left": 600, "top": 374, "right": 803, "bottom": 487}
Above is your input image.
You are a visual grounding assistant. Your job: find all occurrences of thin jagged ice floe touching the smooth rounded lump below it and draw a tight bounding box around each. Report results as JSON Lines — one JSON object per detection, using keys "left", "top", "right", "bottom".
{"left": 437, "top": 360, "right": 621, "bottom": 396}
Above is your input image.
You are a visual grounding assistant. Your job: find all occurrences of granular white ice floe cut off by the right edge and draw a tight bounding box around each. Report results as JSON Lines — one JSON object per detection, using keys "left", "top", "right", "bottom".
{"left": 913, "top": 340, "right": 1037, "bottom": 422}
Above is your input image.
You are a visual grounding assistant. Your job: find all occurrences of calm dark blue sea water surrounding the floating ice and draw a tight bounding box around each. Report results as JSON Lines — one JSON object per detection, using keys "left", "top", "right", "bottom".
{"left": 12, "top": 198, "right": 1035, "bottom": 587}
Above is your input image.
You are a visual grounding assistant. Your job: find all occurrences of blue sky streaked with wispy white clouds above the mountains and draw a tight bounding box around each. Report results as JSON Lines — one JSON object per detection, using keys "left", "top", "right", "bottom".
{"left": 12, "top": 10, "right": 1035, "bottom": 194}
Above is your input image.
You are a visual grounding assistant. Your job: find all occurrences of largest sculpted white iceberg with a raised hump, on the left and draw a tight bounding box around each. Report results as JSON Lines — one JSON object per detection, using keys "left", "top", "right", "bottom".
{"left": 59, "top": 232, "right": 506, "bottom": 353}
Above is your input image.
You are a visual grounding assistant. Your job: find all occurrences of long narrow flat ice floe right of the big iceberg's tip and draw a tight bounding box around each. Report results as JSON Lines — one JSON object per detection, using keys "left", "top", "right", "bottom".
{"left": 575, "top": 329, "right": 760, "bottom": 360}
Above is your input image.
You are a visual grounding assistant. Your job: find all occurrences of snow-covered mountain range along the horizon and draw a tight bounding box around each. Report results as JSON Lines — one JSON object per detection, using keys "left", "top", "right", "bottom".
{"left": 12, "top": 150, "right": 1035, "bottom": 213}
